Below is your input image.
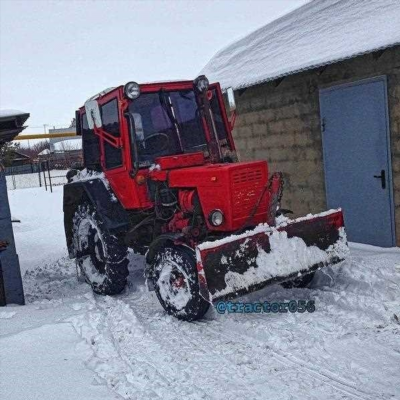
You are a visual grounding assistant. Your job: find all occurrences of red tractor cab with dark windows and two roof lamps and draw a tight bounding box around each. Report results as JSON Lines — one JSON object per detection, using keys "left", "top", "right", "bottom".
{"left": 76, "top": 76, "right": 241, "bottom": 209}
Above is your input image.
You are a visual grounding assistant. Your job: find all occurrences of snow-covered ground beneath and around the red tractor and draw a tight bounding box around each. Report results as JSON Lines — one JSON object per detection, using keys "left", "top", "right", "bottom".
{"left": 0, "top": 187, "right": 400, "bottom": 400}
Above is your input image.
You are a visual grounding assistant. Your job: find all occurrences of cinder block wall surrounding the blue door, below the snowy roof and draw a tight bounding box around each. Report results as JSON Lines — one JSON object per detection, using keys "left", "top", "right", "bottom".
{"left": 233, "top": 46, "right": 400, "bottom": 246}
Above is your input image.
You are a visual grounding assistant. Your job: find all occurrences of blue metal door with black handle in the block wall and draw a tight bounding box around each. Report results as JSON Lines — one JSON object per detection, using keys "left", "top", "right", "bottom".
{"left": 320, "top": 77, "right": 395, "bottom": 247}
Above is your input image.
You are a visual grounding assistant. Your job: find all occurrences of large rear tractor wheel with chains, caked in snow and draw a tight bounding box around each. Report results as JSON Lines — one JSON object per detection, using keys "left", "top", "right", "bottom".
{"left": 73, "top": 204, "right": 129, "bottom": 295}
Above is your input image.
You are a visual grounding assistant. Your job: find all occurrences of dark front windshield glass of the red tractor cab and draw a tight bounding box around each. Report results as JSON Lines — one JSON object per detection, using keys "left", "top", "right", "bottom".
{"left": 129, "top": 90, "right": 226, "bottom": 167}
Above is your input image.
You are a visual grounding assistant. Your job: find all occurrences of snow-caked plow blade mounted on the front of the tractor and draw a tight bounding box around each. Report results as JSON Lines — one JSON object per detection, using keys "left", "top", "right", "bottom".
{"left": 196, "top": 209, "right": 348, "bottom": 301}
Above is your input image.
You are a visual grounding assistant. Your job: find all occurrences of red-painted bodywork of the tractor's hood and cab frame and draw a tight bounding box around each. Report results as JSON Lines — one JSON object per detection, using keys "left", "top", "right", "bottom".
{"left": 80, "top": 81, "right": 276, "bottom": 232}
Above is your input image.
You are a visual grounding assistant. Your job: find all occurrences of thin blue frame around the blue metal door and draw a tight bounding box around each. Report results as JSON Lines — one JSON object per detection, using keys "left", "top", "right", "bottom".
{"left": 318, "top": 75, "right": 396, "bottom": 246}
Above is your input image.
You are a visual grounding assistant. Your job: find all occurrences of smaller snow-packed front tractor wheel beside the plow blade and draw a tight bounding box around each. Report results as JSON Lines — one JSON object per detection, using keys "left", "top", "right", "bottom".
{"left": 152, "top": 244, "right": 210, "bottom": 321}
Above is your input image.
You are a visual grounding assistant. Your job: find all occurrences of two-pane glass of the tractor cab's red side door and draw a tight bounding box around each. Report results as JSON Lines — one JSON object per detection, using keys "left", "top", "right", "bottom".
{"left": 100, "top": 99, "right": 122, "bottom": 169}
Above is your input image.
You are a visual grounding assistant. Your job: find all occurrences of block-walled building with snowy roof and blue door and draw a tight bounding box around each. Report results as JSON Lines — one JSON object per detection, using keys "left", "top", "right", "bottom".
{"left": 202, "top": 0, "right": 400, "bottom": 246}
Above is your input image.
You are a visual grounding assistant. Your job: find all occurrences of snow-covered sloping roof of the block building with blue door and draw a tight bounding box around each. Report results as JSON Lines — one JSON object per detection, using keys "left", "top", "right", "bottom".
{"left": 201, "top": 0, "right": 400, "bottom": 89}
